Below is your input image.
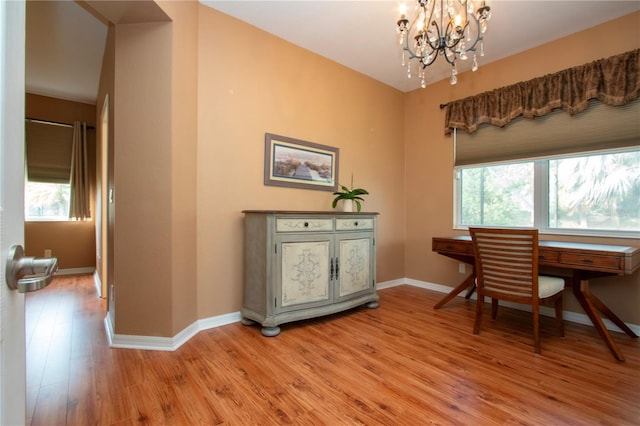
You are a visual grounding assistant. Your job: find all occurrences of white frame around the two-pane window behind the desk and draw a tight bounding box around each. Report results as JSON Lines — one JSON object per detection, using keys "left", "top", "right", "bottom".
{"left": 453, "top": 146, "right": 640, "bottom": 239}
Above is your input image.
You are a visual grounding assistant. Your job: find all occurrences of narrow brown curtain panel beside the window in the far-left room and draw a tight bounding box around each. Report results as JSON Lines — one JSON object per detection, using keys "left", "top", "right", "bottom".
{"left": 69, "top": 121, "right": 91, "bottom": 220}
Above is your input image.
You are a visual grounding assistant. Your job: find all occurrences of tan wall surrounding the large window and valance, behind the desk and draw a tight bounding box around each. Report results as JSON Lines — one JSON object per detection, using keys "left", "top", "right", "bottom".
{"left": 405, "top": 13, "right": 640, "bottom": 324}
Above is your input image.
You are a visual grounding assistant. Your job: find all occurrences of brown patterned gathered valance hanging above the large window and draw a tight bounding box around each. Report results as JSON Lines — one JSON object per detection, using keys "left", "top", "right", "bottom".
{"left": 445, "top": 49, "right": 640, "bottom": 134}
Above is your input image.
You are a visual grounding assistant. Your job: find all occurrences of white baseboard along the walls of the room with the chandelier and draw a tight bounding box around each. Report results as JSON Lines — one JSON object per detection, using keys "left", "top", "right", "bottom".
{"left": 104, "top": 278, "right": 640, "bottom": 351}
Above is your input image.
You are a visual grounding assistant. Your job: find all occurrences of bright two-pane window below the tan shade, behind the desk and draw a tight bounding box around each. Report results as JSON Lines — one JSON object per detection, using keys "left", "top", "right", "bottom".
{"left": 455, "top": 149, "right": 640, "bottom": 237}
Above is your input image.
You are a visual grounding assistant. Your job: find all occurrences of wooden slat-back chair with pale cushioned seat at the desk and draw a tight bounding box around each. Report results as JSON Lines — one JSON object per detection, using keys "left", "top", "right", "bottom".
{"left": 469, "top": 228, "right": 564, "bottom": 354}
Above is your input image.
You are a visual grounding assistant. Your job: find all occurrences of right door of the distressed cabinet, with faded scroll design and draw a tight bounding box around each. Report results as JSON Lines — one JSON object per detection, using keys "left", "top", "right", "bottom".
{"left": 337, "top": 233, "right": 374, "bottom": 298}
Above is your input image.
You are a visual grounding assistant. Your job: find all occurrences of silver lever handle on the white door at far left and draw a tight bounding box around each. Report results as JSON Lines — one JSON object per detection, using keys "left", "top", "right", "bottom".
{"left": 6, "top": 245, "right": 58, "bottom": 293}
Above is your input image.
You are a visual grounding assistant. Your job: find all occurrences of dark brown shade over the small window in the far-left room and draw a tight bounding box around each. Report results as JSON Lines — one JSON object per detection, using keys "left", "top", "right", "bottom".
{"left": 25, "top": 120, "right": 73, "bottom": 183}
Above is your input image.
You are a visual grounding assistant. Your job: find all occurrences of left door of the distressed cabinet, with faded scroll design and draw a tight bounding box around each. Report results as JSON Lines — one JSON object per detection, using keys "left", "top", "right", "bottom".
{"left": 276, "top": 236, "right": 332, "bottom": 311}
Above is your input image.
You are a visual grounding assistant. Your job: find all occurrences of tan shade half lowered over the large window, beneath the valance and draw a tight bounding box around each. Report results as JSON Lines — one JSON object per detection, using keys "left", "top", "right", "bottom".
{"left": 454, "top": 100, "right": 640, "bottom": 166}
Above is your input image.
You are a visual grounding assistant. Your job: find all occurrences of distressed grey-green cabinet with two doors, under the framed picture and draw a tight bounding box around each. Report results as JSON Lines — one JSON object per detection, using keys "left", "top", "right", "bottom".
{"left": 241, "top": 210, "right": 378, "bottom": 336}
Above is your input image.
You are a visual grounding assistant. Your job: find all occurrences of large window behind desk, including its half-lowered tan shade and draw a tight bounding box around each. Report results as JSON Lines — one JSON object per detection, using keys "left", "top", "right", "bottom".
{"left": 453, "top": 100, "right": 640, "bottom": 238}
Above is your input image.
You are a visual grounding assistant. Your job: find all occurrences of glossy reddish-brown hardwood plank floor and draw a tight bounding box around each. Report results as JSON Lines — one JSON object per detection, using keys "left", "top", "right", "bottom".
{"left": 26, "top": 276, "right": 640, "bottom": 425}
